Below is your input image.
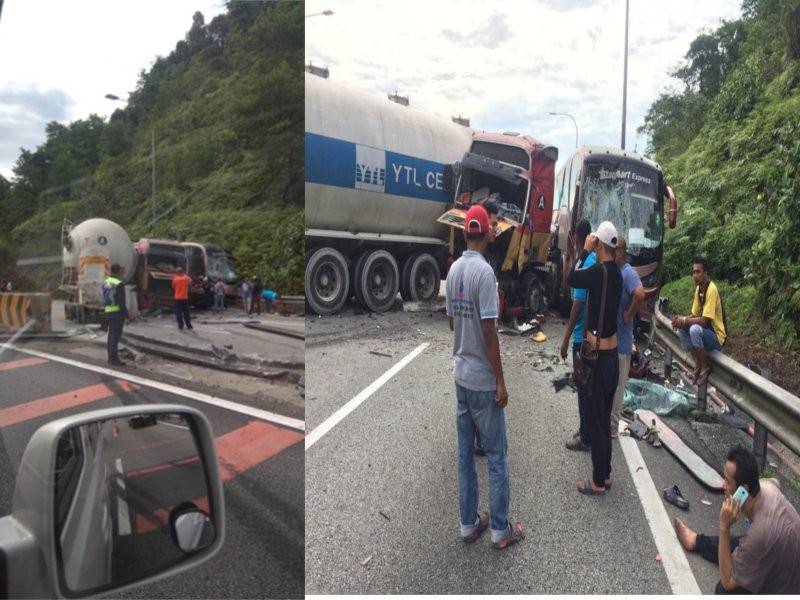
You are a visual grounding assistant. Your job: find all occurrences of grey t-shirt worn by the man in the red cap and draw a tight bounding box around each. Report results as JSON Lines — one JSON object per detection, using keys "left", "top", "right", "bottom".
{"left": 446, "top": 250, "right": 497, "bottom": 392}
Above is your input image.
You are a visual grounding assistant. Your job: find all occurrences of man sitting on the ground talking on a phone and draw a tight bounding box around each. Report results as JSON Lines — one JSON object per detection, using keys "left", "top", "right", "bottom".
{"left": 675, "top": 446, "right": 800, "bottom": 594}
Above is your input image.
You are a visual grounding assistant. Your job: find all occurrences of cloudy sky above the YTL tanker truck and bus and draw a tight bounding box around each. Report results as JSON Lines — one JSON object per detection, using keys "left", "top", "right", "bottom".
{"left": 306, "top": 0, "right": 741, "bottom": 170}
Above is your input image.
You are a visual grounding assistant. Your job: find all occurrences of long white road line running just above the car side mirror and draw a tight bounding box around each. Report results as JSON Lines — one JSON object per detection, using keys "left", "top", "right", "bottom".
{"left": 0, "top": 344, "right": 306, "bottom": 432}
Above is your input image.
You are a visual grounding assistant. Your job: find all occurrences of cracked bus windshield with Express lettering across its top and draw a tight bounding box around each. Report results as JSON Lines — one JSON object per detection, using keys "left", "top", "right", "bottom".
{"left": 581, "top": 160, "right": 663, "bottom": 258}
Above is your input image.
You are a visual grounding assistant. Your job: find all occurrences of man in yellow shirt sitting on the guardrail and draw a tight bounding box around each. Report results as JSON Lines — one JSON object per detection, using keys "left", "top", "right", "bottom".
{"left": 672, "top": 256, "right": 727, "bottom": 385}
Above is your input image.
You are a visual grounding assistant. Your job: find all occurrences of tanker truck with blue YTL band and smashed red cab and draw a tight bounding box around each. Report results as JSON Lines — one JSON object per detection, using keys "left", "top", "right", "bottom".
{"left": 305, "top": 74, "right": 558, "bottom": 322}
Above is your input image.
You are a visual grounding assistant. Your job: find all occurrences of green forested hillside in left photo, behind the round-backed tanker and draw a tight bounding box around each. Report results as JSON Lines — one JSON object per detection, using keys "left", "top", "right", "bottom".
{"left": 0, "top": 0, "right": 304, "bottom": 294}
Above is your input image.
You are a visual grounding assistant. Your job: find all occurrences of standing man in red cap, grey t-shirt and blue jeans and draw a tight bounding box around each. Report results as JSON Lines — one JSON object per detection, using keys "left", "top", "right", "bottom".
{"left": 446, "top": 205, "right": 525, "bottom": 549}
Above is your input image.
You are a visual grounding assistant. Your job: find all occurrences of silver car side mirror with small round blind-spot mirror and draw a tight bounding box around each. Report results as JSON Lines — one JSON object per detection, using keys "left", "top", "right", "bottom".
{"left": 0, "top": 404, "right": 225, "bottom": 598}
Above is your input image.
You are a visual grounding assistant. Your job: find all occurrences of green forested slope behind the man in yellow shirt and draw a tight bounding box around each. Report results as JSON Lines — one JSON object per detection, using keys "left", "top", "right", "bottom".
{"left": 641, "top": 0, "right": 800, "bottom": 362}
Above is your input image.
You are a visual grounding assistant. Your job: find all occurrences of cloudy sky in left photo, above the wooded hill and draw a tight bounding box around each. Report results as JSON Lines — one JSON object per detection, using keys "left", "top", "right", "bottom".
{"left": 0, "top": 0, "right": 225, "bottom": 178}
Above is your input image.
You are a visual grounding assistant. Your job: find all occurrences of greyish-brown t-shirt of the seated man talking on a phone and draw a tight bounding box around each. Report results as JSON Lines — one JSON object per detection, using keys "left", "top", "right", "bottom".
{"left": 732, "top": 479, "right": 800, "bottom": 594}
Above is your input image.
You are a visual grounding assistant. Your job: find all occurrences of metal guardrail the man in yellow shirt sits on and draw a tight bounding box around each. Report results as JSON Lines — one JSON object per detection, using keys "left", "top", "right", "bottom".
{"left": 654, "top": 302, "right": 800, "bottom": 469}
